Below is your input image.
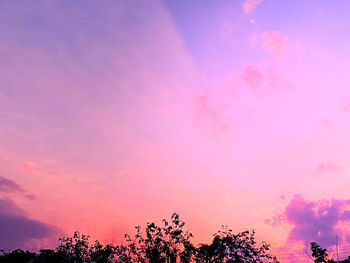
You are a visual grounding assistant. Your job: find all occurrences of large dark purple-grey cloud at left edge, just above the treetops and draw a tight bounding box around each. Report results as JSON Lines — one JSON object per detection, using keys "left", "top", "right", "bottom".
{"left": 0, "top": 199, "right": 62, "bottom": 250}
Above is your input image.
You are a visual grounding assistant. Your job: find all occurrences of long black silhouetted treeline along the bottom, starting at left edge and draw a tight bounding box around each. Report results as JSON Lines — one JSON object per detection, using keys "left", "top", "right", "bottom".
{"left": 0, "top": 213, "right": 278, "bottom": 263}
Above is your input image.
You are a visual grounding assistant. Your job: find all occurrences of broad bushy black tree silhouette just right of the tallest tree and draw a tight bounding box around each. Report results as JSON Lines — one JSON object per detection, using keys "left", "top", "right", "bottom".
{"left": 195, "top": 227, "right": 278, "bottom": 263}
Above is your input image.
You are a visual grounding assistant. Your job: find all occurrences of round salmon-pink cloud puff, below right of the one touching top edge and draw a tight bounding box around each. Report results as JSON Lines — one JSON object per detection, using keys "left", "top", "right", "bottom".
{"left": 262, "top": 30, "right": 287, "bottom": 56}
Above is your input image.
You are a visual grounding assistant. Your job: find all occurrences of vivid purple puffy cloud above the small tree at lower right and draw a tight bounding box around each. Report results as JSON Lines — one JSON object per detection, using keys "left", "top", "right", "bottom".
{"left": 284, "top": 195, "right": 350, "bottom": 247}
